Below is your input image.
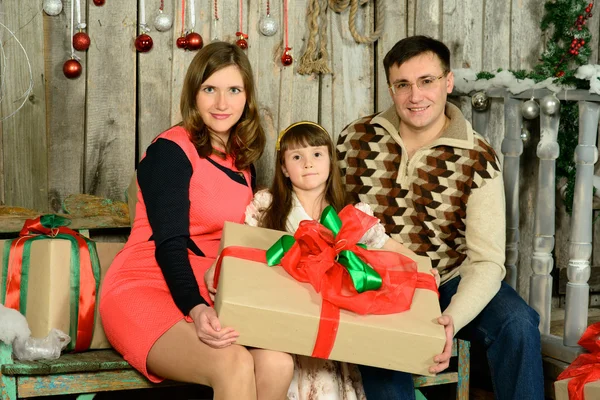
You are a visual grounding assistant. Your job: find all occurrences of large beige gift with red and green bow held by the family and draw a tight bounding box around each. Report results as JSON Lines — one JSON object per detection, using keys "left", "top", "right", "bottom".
{"left": 215, "top": 207, "right": 446, "bottom": 375}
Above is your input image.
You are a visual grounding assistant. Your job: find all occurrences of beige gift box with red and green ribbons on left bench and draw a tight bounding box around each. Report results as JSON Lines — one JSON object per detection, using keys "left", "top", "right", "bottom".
{"left": 0, "top": 216, "right": 124, "bottom": 350}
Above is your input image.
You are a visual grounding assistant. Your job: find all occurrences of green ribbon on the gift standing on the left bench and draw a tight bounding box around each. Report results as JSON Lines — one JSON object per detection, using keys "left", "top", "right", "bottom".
{"left": 0, "top": 214, "right": 100, "bottom": 351}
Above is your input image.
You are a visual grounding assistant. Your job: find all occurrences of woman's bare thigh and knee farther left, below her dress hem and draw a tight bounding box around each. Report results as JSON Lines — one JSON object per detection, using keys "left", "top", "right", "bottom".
{"left": 146, "top": 320, "right": 256, "bottom": 400}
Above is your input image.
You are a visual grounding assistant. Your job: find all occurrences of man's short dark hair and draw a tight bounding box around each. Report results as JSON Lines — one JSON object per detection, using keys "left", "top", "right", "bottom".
{"left": 383, "top": 35, "right": 450, "bottom": 83}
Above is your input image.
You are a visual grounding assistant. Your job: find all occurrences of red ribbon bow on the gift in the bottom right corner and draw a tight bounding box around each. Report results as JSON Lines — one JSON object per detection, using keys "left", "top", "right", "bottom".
{"left": 556, "top": 322, "right": 600, "bottom": 400}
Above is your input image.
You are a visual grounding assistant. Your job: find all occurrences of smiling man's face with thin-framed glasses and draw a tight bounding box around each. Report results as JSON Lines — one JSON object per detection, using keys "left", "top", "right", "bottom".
{"left": 389, "top": 53, "right": 454, "bottom": 133}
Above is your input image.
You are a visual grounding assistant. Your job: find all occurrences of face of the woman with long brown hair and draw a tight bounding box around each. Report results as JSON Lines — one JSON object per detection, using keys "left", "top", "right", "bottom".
{"left": 196, "top": 65, "right": 246, "bottom": 142}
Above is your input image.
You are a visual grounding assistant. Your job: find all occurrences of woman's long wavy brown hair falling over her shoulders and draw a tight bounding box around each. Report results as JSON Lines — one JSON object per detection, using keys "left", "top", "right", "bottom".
{"left": 180, "top": 42, "right": 266, "bottom": 171}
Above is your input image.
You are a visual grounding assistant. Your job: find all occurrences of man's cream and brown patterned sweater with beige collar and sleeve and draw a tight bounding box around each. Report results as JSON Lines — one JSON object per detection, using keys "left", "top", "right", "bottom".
{"left": 337, "top": 103, "right": 506, "bottom": 333}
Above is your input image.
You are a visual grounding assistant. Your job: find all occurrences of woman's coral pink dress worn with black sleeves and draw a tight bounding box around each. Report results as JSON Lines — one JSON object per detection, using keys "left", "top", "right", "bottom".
{"left": 100, "top": 127, "right": 252, "bottom": 382}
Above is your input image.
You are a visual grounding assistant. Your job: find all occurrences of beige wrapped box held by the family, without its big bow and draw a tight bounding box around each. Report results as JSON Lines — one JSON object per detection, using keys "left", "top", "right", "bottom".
{"left": 215, "top": 212, "right": 446, "bottom": 375}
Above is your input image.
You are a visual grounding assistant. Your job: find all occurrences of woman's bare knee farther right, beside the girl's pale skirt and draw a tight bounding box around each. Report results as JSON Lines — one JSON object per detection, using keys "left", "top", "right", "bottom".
{"left": 249, "top": 349, "right": 294, "bottom": 400}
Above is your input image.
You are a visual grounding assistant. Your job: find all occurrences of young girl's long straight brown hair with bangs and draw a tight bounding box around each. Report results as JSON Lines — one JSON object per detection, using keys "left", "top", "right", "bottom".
{"left": 259, "top": 122, "right": 346, "bottom": 231}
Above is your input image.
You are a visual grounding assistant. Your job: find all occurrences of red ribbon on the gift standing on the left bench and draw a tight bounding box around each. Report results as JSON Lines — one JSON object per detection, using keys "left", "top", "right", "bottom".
{"left": 4, "top": 216, "right": 99, "bottom": 351}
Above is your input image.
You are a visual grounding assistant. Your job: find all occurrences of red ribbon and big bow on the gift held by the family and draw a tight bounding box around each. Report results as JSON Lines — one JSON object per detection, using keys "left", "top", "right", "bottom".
{"left": 214, "top": 206, "right": 439, "bottom": 358}
